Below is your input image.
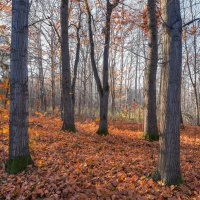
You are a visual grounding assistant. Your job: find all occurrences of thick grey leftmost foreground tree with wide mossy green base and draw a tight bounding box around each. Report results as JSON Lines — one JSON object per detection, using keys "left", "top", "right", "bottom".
{"left": 6, "top": 0, "right": 33, "bottom": 173}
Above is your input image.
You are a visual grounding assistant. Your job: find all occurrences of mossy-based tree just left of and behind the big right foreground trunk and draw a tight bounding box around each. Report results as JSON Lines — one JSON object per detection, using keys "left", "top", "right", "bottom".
{"left": 144, "top": 0, "right": 159, "bottom": 140}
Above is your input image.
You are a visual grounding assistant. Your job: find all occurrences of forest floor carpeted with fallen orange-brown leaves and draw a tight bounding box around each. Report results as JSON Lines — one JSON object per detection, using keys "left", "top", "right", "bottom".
{"left": 0, "top": 111, "right": 200, "bottom": 200}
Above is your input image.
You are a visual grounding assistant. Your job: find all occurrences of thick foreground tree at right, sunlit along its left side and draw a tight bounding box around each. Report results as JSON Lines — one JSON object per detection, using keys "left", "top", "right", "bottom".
{"left": 154, "top": 0, "right": 182, "bottom": 185}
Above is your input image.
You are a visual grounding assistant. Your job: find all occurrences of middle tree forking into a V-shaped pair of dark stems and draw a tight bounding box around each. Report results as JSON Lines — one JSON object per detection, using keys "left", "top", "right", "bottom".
{"left": 85, "top": 0, "right": 119, "bottom": 135}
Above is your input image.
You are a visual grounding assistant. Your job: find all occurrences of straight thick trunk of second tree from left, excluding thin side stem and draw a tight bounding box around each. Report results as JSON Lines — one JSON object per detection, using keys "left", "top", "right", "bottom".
{"left": 61, "top": 0, "right": 76, "bottom": 132}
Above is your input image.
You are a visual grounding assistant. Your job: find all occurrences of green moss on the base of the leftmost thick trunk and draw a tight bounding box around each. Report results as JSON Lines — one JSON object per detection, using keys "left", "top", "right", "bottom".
{"left": 6, "top": 155, "right": 33, "bottom": 174}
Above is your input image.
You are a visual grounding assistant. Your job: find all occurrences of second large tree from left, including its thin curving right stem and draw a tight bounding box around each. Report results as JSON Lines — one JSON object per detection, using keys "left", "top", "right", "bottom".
{"left": 61, "top": 0, "right": 82, "bottom": 132}
